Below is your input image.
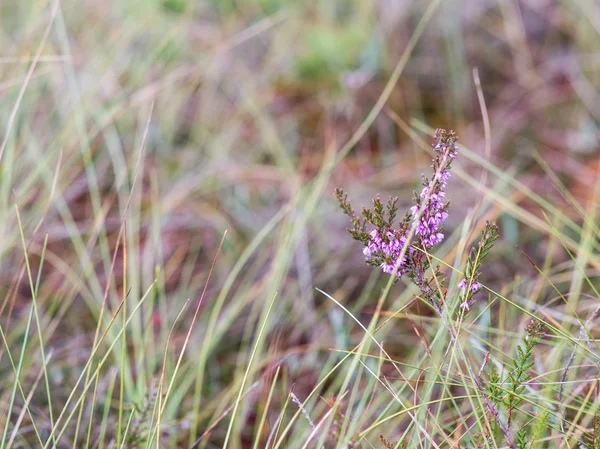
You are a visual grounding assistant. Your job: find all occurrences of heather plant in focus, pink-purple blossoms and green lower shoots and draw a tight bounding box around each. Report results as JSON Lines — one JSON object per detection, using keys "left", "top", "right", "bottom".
{"left": 335, "top": 129, "right": 564, "bottom": 449}
